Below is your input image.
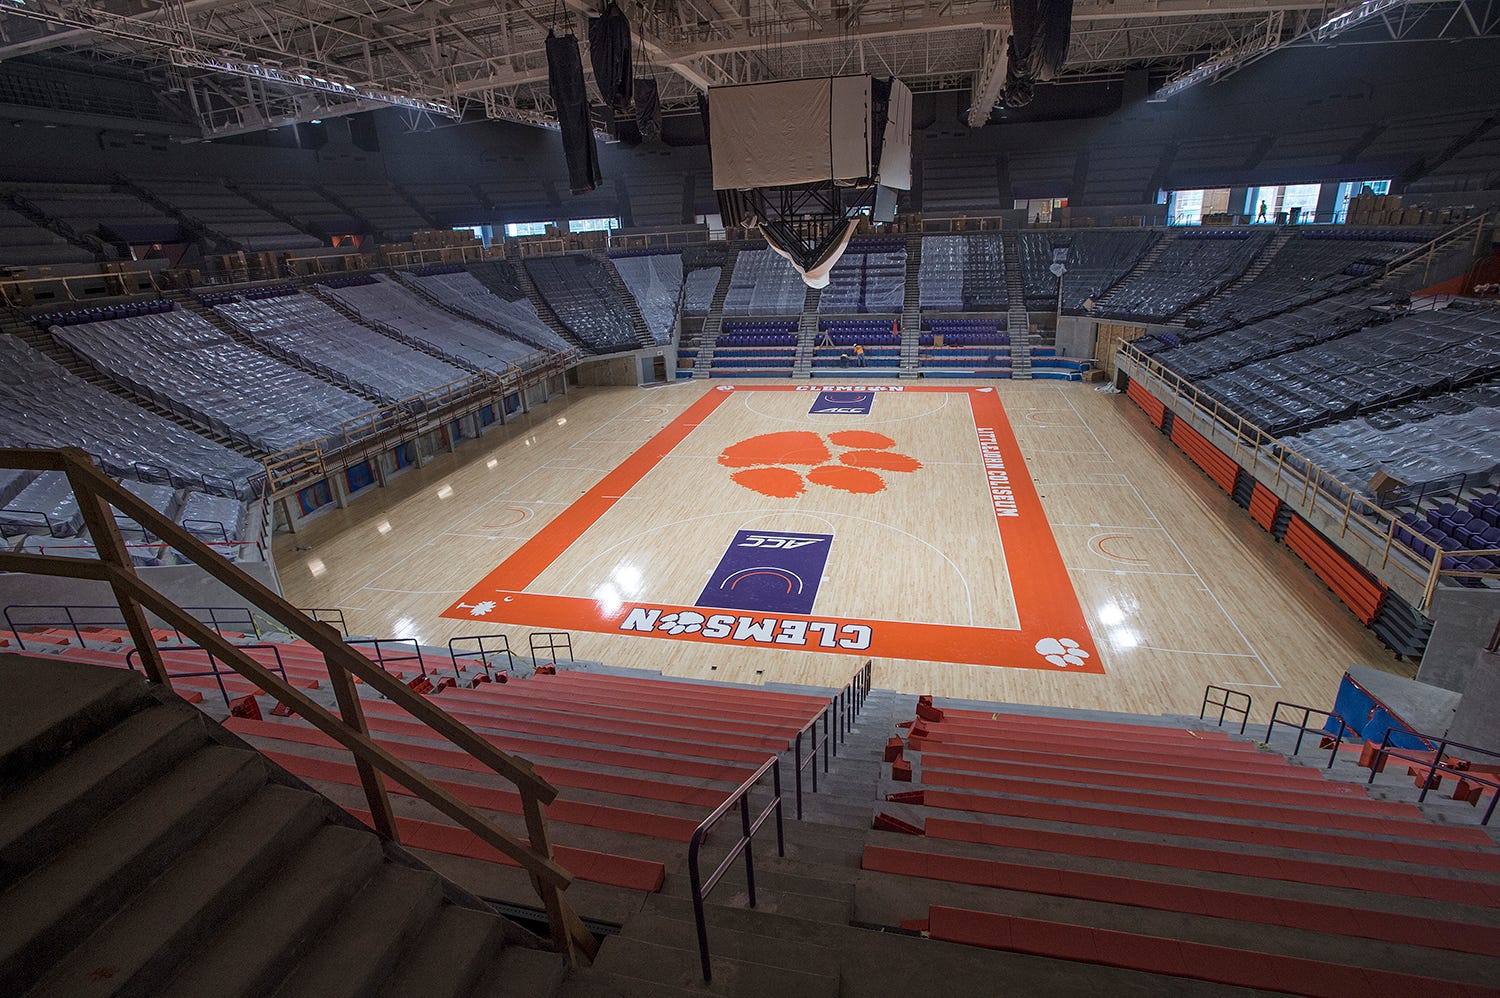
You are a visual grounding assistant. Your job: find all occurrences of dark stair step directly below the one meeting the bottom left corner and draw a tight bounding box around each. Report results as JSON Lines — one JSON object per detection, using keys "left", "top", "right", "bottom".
{"left": 20, "top": 785, "right": 327, "bottom": 998}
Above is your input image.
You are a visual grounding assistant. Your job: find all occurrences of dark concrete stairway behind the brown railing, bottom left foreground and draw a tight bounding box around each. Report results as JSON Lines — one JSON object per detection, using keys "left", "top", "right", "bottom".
{"left": 0, "top": 654, "right": 566, "bottom": 998}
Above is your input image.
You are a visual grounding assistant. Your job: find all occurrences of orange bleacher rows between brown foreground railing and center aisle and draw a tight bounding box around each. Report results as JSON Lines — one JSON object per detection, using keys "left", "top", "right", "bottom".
{"left": 8, "top": 629, "right": 830, "bottom": 891}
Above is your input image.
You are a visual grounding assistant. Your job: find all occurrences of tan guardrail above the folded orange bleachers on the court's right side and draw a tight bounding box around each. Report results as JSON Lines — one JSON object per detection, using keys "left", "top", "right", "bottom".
{"left": 1116, "top": 336, "right": 1500, "bottom": 611}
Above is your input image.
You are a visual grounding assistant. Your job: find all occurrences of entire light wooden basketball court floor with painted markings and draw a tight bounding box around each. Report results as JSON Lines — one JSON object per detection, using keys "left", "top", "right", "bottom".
{"left": 276, "top": 380, "right": 1415, "bottom": 717}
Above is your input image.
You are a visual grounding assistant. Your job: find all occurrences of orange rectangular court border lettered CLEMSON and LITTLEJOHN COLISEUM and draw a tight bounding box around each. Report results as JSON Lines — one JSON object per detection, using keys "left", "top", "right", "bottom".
{"left": 443, "top": 384, "right": 1104, "bottom": 674}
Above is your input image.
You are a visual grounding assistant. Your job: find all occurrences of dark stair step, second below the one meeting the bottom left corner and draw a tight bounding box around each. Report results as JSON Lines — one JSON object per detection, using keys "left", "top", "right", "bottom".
{"left": 158, "top": 825, "right": 381, "bottom": 998}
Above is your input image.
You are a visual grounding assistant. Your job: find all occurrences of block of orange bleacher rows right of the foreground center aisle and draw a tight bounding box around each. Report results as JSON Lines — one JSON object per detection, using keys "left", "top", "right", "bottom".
{"left": 861, "top": 698, "right": 1500, "bottom": 998}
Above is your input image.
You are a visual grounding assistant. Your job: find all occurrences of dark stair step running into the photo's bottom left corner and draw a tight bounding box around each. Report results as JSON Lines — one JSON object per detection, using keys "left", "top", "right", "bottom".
{"left": 0, "top": 744, "right": 266, "bottom": 993}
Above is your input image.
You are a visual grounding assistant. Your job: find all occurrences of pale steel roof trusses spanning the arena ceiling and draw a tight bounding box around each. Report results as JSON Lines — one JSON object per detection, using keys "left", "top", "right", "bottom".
{"left": 0, "top": 0, "right": 1500, "bottom": 138}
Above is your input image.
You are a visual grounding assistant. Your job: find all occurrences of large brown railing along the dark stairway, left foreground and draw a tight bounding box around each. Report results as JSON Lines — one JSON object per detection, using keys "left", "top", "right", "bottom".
{"left": 0, "top": 447, "right": 599, "bottom": 959}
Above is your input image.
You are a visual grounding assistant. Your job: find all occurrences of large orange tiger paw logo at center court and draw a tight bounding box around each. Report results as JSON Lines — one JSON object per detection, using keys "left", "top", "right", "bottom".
{"left": 719, "top": 429, "right": 923, "bottom": 498}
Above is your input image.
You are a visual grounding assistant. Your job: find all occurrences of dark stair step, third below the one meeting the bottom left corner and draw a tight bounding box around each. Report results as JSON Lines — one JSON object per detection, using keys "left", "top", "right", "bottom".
{"left": 276, "top": 863, "right": 443, "bottom": 998}
